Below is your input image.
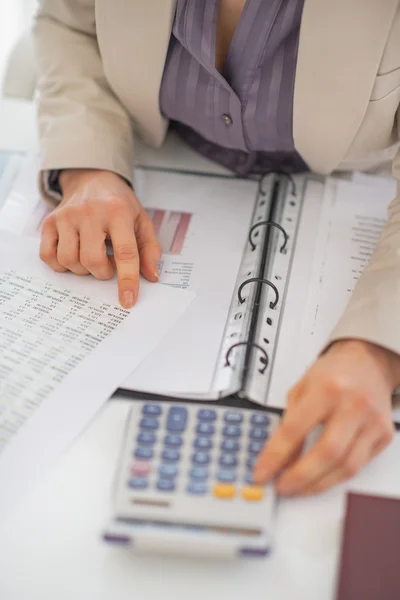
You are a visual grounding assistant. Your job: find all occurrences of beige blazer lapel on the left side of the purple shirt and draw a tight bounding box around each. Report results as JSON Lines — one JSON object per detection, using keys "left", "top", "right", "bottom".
{"left": 96, "top": 0, "right": 176, "bottom": 146}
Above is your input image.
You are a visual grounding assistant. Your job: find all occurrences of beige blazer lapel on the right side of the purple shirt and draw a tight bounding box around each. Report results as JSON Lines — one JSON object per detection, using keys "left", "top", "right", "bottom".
{"left": 293, "top": 0, "right": 399, "bottom": 173}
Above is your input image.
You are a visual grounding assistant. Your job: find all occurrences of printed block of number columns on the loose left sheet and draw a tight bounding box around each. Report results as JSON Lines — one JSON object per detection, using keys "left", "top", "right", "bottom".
{"left": 0, "top": 268, "right": 125, "bottom": 453}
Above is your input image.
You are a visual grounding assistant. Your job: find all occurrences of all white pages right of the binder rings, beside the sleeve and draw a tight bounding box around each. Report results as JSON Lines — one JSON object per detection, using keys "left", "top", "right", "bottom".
{"left": 268, "top": 176, "right": 400, "bottom": 422}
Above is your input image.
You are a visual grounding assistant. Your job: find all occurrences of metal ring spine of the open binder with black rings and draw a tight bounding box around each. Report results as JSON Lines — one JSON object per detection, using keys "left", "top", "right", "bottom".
{"left": 214, "top": 173, "right": 305, "bottom": 404}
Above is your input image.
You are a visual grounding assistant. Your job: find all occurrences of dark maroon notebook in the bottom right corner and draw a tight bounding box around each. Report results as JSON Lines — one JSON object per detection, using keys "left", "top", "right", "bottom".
{"left": 336, "top": 492, "right": 400, "bottom": 600}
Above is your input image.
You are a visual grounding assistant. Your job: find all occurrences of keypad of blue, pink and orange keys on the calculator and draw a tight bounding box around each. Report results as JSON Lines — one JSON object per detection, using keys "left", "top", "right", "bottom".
{"left": 127, "top": 403, "right": 271, "bottom": 502}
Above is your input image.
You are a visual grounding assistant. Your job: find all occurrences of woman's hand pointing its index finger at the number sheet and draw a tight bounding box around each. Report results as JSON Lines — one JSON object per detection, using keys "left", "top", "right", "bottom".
{"left": 40, "top": 169, "right": 161, "bottom": 308}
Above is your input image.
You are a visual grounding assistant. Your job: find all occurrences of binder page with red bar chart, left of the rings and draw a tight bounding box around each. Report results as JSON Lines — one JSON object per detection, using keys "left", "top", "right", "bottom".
{"left": 122, "top": 166, "right": 258, "bottom": 395}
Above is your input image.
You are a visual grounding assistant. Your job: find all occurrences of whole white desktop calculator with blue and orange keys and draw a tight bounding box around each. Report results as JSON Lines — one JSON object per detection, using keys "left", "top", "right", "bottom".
{"left": 103, "top": 400, "right": 279, "bottom": 557}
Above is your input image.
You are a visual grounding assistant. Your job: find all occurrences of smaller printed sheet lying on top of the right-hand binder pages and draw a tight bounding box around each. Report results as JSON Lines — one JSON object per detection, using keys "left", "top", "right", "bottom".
{"left": 299, "top": 176, "right": 396, "bottom": 366}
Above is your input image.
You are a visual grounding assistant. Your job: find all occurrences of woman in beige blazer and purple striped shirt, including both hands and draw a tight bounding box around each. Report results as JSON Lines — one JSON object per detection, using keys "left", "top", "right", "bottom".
{"left": 35, "top": 0, "right": 400, "bottom": 495}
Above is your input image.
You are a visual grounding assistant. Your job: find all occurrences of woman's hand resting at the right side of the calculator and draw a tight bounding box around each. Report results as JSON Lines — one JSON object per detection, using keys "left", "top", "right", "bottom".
{"left": 254, "top": 340, "right": 400, "bottom": 496}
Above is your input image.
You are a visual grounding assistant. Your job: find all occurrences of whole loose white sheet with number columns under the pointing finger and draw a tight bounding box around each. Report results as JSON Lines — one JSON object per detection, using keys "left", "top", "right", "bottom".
{"left": 0, "top": 232, "right": 194, "bottom": 520}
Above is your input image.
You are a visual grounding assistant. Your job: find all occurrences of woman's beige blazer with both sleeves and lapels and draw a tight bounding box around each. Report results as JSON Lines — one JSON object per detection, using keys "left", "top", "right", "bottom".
{"left": 35, "top": 0, "right": 400, "bottom": 353}
